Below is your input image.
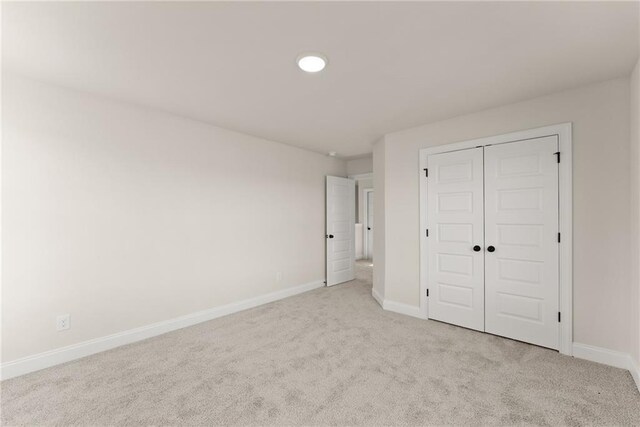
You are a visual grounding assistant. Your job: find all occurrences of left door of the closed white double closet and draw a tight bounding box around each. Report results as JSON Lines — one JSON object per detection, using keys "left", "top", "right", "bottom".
{"left": 427, "top": 148, "right": 484, "bottom": 331}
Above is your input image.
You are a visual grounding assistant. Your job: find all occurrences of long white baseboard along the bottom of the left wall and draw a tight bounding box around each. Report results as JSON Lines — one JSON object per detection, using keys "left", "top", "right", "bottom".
{"left": 0, "top": 279, "right": 324, "bottom": 380}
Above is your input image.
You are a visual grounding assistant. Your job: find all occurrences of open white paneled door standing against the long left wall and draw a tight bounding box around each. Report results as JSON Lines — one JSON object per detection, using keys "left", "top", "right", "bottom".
{"left": 326, "top": 176, "right": 356, "bottom": 286}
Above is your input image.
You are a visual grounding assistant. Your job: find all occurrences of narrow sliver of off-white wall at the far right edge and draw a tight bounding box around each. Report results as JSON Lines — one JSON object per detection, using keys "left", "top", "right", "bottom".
{"left": 629, "top": 57, "right": 640, "bottom": 370}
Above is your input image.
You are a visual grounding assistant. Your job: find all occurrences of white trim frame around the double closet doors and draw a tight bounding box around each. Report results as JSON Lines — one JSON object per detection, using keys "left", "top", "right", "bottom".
{"left": 418, "top": 122, "right": 573, "bottom": 356}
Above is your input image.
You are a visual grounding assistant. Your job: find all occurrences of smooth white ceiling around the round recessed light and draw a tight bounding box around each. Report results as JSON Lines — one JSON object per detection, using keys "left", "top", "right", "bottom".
{"left": 2, "top": 2, "right": 640, "bottom": 157}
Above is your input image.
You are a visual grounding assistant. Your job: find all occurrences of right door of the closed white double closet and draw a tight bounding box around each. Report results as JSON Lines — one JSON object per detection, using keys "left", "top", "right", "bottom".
{"left": 484, "top": 136, "right": 559, "bottom": 349}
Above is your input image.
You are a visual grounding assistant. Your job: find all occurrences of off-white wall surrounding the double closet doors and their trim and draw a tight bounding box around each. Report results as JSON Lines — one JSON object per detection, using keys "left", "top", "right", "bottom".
{"left": 374, "top": 78, "right": 631, "bottom": 353}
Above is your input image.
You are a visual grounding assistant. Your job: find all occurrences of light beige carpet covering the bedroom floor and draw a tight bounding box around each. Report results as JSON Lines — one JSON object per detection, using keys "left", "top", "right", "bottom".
{"left": 1, "top": 263, "right": 640, "bottom": 425}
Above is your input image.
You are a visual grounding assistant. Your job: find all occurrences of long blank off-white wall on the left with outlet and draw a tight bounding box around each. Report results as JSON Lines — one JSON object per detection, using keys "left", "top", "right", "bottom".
{"left": 2, "top": 73, "right": 346, "bottom": 362}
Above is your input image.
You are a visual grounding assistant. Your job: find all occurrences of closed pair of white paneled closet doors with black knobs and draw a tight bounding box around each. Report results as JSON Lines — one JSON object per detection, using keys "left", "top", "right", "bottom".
{"left": 427, "top": 136, "right": 559, "bottom": 349}
